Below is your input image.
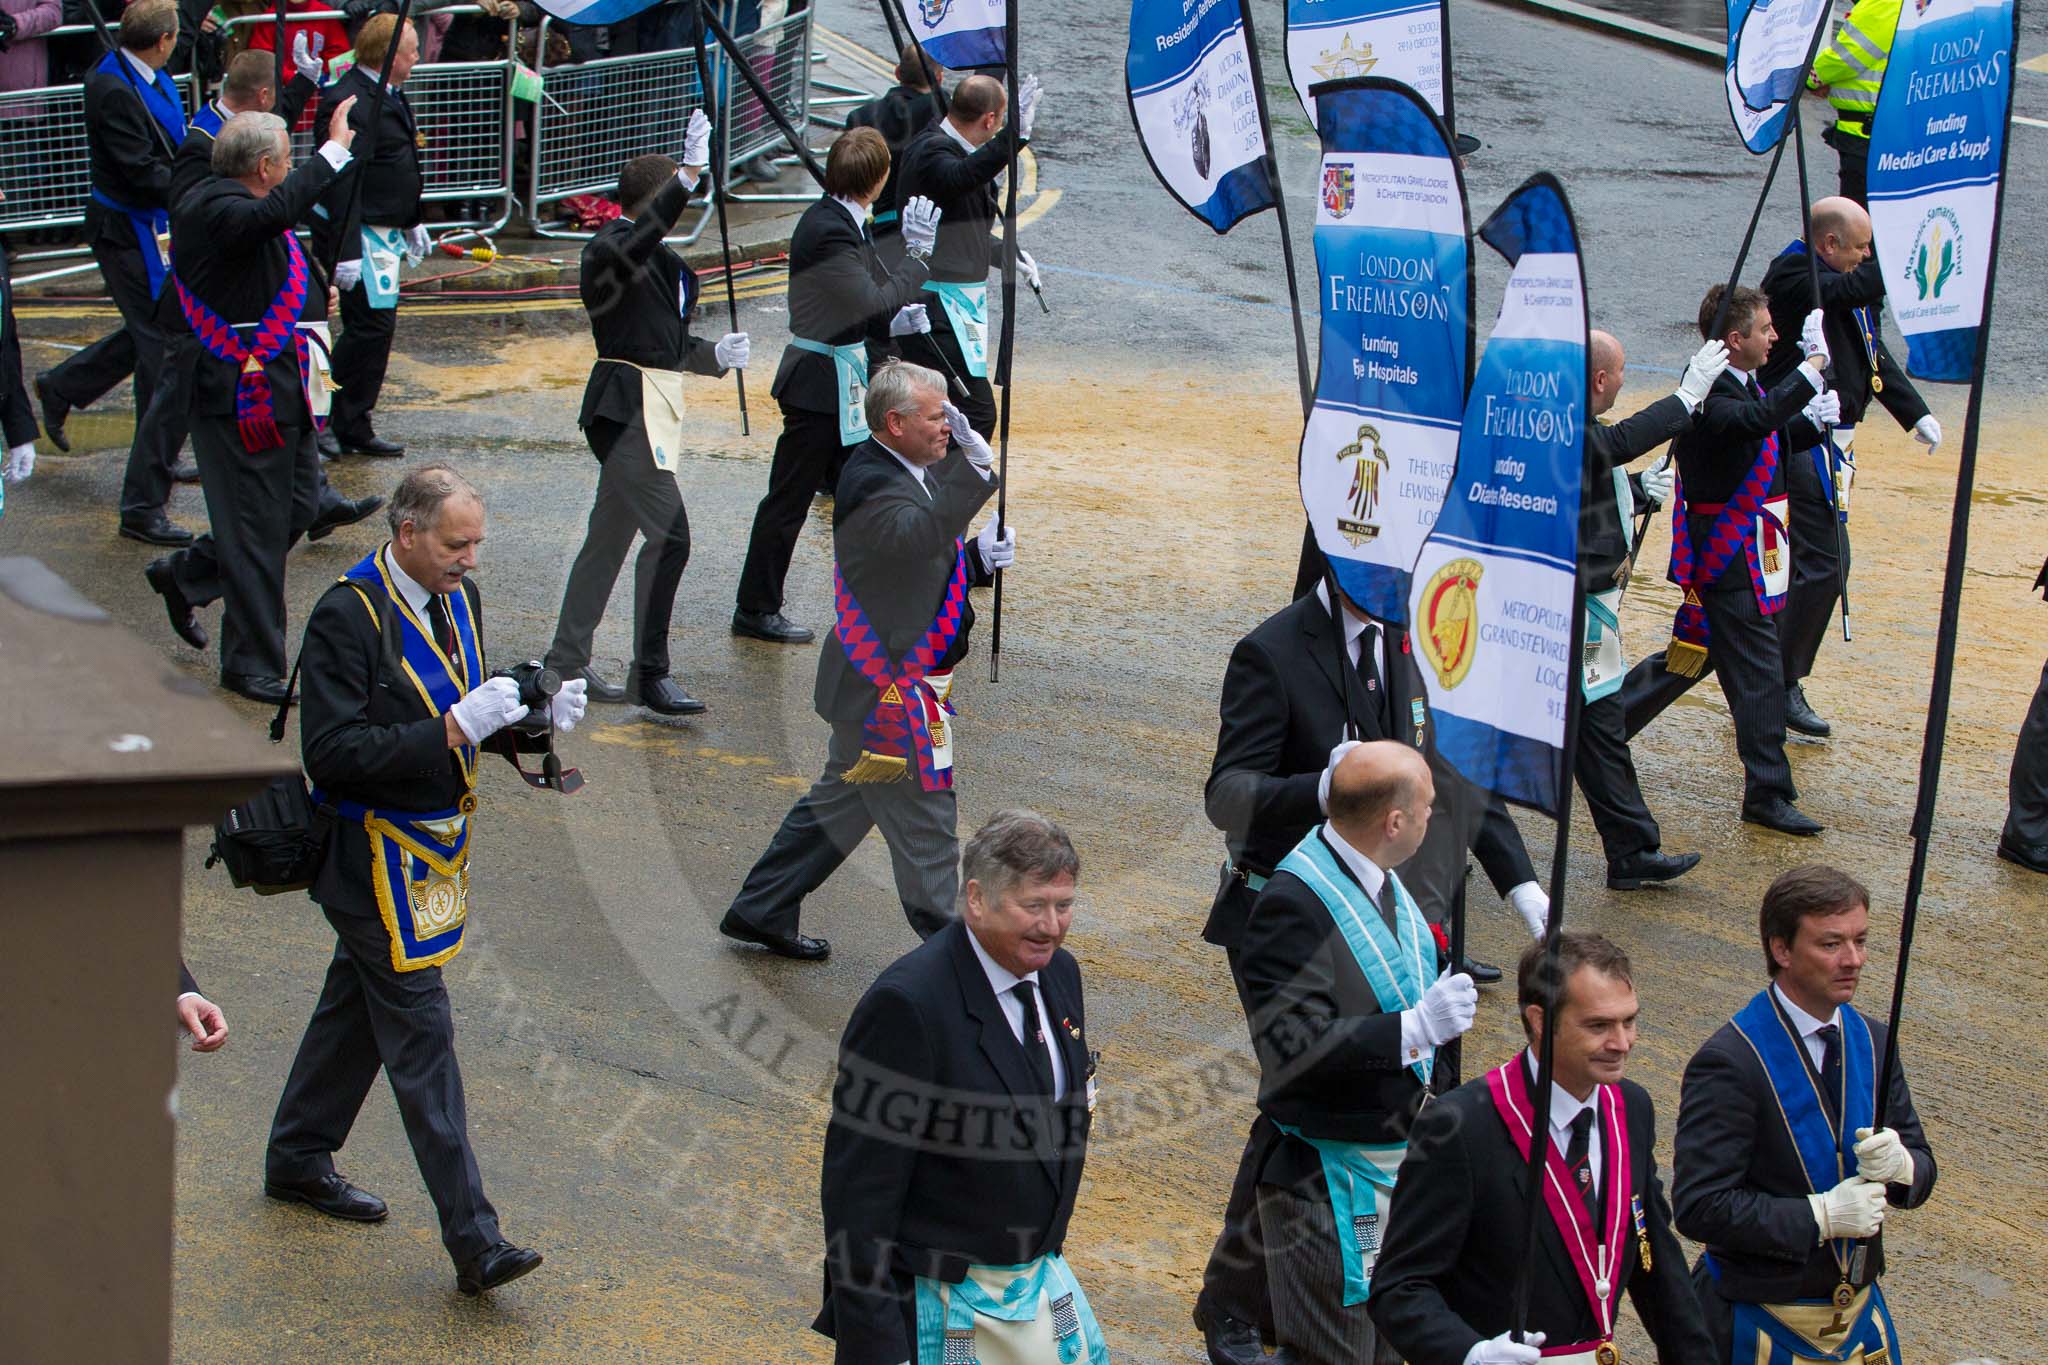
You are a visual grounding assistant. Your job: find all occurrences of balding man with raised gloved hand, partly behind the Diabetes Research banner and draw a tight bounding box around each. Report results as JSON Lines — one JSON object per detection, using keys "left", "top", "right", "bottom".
{"left": 1573, "top": 332, "right": 1729, "bottom": 890}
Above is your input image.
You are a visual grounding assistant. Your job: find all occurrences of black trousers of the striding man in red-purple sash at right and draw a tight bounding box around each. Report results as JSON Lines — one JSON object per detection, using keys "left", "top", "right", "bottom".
{"left": 1622, "top": 585, "right": 1798, "bottom": 806}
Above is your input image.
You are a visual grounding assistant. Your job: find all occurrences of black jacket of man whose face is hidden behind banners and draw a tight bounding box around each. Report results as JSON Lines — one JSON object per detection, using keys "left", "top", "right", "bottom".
{"left": 1202, "top": 593, "right": 1536, "bottom": 948}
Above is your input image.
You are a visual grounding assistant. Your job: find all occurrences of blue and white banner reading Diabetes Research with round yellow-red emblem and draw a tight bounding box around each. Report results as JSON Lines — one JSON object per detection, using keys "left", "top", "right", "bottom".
{"left": 1409, "top": 172, "right": 1587, "bottom": 814}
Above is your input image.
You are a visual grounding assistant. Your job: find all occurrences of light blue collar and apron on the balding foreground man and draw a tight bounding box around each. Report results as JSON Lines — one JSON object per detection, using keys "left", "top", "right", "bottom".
{"left": 1276, "top": 825, "right": 1436, "bottom": 1308}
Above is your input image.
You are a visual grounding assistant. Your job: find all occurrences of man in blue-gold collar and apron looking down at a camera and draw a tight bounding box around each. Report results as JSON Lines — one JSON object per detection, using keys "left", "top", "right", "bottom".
{"left": 264, "top": 466, "right": 584, "bottom": 1295}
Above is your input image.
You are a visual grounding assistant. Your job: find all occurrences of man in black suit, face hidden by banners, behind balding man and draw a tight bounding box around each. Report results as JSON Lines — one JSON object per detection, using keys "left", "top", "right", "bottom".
{"left": 1194, "top": 568, "right": 1550, "bottom": 1365}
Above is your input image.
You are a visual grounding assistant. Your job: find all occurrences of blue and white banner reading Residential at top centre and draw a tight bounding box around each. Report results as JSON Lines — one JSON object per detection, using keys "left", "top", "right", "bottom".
{"left": 1124, "top": 0, "right": 1274, "bottom": 231}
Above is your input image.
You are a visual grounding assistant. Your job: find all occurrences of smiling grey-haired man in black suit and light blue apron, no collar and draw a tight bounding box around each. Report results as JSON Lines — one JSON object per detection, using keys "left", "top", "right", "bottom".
{"left": 811, "top": 810, "right": 1110, "bottom": 1365}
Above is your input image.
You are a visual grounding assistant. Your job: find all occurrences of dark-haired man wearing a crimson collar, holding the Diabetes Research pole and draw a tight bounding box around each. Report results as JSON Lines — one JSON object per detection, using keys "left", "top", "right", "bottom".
{"left": 1370, "top": 931, "right": 1712, "bottom": 1365}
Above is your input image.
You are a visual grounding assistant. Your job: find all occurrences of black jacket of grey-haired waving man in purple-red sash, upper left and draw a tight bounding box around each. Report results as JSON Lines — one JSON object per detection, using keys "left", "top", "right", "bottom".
{"left": 166, "top": 153, "right": 334, "bottom": 428}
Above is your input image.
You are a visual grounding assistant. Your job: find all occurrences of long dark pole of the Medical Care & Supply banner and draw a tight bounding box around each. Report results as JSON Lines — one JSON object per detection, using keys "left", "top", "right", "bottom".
{"left": 1878, "top": 0, "right": 2019, "bottom": 1128}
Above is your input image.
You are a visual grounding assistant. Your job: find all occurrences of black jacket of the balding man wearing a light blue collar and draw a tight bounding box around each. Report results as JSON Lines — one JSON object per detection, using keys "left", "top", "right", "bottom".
{"left": 1237, "top": 834, "right": 1438, "bottom": 1154}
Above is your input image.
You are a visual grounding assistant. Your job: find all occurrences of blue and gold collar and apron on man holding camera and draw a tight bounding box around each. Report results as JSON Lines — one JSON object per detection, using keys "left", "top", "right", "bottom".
{"left": 313, "top": 551, "right": 483, "bottom": 972}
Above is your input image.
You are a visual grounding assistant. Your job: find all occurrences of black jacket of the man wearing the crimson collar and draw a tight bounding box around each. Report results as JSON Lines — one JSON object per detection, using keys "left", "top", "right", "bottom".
{"left": 1368, "top": 1054, "right": 1714, "bottom": 1365}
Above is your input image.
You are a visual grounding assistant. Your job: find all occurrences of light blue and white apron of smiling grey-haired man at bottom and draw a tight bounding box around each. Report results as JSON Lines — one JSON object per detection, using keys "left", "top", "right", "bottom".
{"left": 915, "top": 1252, "right": 1110, "bottom": 1365}
